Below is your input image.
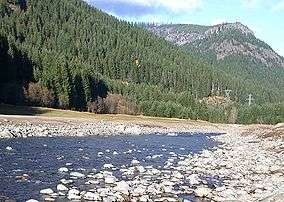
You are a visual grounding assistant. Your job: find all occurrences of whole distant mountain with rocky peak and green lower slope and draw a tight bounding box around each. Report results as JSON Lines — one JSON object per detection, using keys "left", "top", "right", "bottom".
{"left": 144, "top": 22, "right": 284, "bottom": 100}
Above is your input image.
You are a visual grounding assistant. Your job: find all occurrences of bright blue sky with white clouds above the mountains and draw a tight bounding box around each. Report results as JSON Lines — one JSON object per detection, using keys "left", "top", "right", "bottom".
{"left": 85, "top": 0, "right": 284, "bottom": 56}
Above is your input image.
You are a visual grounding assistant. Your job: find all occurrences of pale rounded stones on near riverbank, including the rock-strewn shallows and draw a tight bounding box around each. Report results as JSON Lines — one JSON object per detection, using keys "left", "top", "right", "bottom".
{"left": 18, "top": 125, "right": 284, "bottom": 202}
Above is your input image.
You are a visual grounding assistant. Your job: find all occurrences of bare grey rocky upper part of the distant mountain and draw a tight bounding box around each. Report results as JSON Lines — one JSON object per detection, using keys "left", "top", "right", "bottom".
{"left": 146, "top": 22, "right": 284, "bottom": 68}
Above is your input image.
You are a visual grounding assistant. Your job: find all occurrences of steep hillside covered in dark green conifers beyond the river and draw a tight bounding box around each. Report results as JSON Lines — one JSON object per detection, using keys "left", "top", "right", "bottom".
{"left": 0, "top": 0, "right": 283, "bottom": 122}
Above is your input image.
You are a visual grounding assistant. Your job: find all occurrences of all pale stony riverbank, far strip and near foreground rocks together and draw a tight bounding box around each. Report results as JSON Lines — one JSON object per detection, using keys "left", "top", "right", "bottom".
{"left": 0, "top": 114, "right": 284, "bottom": 202}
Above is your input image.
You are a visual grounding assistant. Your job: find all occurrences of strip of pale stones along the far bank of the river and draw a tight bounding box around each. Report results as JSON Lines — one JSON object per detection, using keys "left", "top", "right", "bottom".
{"left": 0, "top": 116, "right": 224, "bottom": 138}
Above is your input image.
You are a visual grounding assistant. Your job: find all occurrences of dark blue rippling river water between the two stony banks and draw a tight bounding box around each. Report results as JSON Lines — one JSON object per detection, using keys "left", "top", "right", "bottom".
{"left": 0, "top": 133, "right": 220, "bottom": 201}
